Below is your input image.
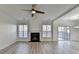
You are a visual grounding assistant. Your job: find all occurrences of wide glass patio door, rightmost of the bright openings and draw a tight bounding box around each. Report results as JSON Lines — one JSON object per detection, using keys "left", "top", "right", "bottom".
{"left": 58, "top": 26, "right": 70, "bottom": 40}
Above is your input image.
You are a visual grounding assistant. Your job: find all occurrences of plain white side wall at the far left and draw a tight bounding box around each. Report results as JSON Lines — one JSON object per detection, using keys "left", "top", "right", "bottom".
{"left": 0, "top": 12, "right": 16, "bottom": 49}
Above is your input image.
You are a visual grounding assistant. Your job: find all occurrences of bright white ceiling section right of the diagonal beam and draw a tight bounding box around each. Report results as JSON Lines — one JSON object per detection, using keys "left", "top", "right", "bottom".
{"left": 60, "top": 5, "right": 79, "bottom": 20}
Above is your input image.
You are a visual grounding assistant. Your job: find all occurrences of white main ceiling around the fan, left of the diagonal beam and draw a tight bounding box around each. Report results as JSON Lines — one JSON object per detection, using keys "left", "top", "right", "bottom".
{"left": 0, "top": 4, "right": 76, "bottom": 20}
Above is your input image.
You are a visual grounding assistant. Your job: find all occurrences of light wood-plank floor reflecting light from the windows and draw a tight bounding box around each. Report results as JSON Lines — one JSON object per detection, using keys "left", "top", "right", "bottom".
{"left": 1, "top": 41, "right": 79, "bottom": 54}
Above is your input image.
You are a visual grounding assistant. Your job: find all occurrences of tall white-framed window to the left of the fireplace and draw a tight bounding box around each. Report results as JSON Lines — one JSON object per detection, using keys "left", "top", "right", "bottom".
{"left": 18, "top": 25, "right": 28, "bottom": 38}
